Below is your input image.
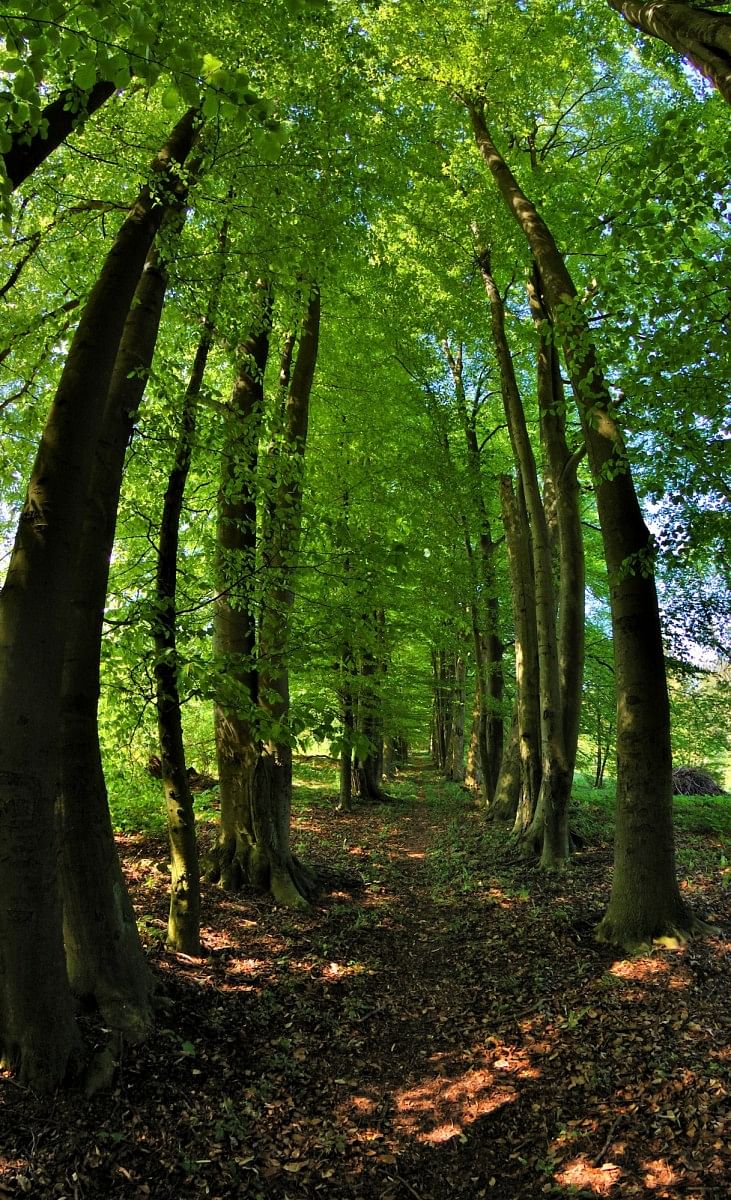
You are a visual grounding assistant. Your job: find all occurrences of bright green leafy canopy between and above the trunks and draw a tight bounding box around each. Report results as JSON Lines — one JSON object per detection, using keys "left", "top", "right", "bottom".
{"left": 0, "top": 0, "right": 729, "bottom": 816}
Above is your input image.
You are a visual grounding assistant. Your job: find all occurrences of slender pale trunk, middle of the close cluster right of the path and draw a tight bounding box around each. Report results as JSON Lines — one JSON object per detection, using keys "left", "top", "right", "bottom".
{"left": 479, "top": 248, "right": 571, "bottom": 869}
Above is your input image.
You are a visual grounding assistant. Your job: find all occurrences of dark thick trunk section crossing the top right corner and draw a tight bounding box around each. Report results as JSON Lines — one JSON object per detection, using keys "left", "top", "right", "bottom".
{"left": 607, "top": 0, "right": 731, "bottom": 104}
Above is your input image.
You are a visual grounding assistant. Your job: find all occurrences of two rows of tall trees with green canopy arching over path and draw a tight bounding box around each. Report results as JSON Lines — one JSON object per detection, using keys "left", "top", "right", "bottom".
{"left": 0, "top": 0, "right": 731, "bottom": 1090}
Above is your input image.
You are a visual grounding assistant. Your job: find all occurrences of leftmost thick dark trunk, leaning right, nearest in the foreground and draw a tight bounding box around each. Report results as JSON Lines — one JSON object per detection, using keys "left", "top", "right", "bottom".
{"left": 0, "top": 112, "right": 194, "bottom": 1090}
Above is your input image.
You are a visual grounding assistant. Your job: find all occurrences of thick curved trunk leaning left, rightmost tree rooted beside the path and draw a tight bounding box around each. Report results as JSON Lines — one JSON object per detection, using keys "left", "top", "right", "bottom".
{"left": 469, "top": 106, "right": 695, "bottom": 946}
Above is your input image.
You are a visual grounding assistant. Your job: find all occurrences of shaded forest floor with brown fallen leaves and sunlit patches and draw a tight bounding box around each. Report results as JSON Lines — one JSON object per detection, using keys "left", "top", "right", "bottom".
{"left": 0, "top": 760, "right": 731, "bottom": 1200}
